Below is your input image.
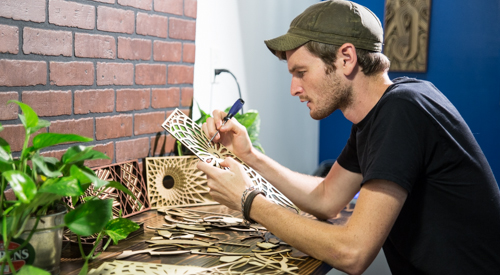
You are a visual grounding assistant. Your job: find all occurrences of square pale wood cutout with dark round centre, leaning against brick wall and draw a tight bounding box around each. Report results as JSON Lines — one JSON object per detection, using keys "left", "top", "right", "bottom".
{"left": 146, "top": 156, "right": 217, "bottom": 208}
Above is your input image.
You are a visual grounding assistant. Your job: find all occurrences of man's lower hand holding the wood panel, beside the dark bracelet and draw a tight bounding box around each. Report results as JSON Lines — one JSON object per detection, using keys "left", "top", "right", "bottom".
{"left": 197, "top": 158, "right": 252, "bottom": 211}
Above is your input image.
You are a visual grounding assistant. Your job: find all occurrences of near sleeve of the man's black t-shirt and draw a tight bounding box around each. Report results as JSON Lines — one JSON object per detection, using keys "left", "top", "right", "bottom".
{"left": 358, "top": 98, "right": 430, "bottom": 192}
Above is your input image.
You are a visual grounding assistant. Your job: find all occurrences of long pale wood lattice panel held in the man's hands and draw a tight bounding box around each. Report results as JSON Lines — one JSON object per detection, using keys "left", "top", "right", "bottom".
{"left": 162, "top": 109, "right": 299, "bottom": 213}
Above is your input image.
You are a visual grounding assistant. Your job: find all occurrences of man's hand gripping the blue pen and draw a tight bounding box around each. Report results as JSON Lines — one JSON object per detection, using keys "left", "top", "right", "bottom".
{"left": 201, "top": 110, "right": 253, "bottom": 160}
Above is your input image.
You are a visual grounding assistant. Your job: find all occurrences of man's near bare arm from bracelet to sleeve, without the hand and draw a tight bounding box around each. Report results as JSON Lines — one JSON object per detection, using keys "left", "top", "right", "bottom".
{"left": 250, "top": 180, "right": 407, "bottom": 274}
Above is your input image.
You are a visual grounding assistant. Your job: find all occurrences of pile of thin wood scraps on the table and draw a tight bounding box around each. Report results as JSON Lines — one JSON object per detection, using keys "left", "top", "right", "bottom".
{"left": 110, "top": 208, "right": 303, "bottom": 274}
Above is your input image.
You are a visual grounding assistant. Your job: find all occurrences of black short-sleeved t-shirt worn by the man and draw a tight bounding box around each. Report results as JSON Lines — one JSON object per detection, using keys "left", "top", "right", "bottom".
{"left": 337, "top": 78, "right": 500, "bottom": 275}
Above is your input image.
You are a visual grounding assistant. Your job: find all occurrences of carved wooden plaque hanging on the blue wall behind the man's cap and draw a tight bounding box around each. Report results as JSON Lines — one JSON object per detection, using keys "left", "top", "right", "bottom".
{"left": 384, "top": 0, "right": 431, "bottom": 72}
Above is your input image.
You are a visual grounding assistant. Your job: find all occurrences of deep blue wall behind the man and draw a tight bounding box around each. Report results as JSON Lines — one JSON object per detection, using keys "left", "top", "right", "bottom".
{"left": 319, "top": 0, "right": 500, "bottom": 182}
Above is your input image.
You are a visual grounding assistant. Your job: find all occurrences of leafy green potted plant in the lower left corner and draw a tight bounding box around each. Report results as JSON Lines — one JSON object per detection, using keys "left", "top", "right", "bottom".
{"left": 0, "top": 101, "right": 139, "bottom": 274}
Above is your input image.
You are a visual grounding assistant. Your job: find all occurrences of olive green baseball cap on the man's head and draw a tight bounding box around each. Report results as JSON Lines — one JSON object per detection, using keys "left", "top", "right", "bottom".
{"left": 264, "top": 0, "right": 384, "bottom": 54}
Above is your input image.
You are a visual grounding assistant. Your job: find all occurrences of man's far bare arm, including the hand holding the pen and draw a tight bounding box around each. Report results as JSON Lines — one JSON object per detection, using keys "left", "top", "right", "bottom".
{"left": 202, "top": 110, "right": 362, "bottom": 219}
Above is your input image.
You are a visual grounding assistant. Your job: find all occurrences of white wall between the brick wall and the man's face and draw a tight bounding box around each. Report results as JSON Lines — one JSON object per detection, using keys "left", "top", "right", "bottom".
{"left": 193, "top": 0, "right": 319, "bottom": 174}
